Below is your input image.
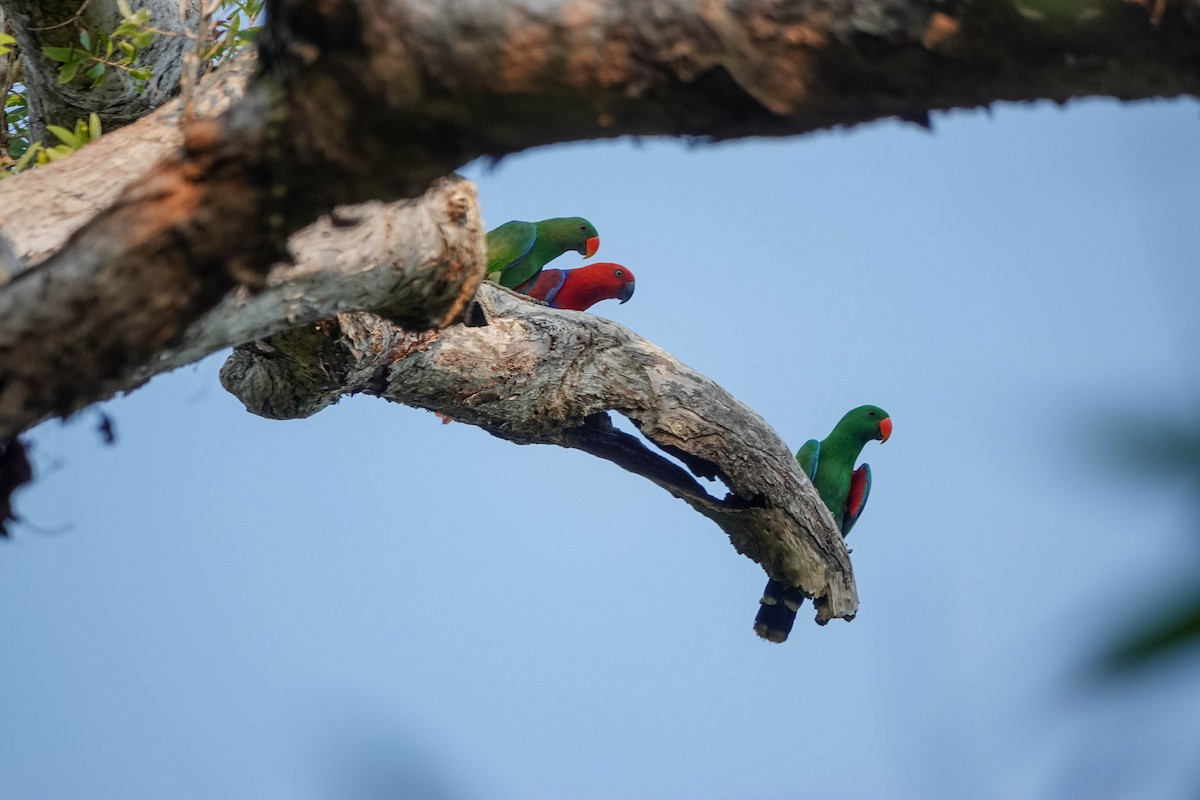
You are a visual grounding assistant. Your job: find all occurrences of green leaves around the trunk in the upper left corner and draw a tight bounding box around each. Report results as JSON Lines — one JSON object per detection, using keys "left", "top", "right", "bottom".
{"left": 0, "top": 0, "right": 265, "bottom": 178}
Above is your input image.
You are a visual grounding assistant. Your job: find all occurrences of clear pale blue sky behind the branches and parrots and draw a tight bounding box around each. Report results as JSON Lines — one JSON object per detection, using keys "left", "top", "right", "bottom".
{"left": 0, "top": 101, "right": 1200, "bottom": 800}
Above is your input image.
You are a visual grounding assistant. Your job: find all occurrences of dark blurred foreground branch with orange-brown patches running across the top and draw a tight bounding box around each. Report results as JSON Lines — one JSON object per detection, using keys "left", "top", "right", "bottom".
{"left": 0, "top": 0, "right": 1200, "bottom": 441}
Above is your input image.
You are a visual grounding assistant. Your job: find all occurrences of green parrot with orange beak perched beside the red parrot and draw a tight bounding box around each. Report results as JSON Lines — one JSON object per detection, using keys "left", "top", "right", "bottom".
{"left": 487, "top": 217, "right": 600, "bottom": 289}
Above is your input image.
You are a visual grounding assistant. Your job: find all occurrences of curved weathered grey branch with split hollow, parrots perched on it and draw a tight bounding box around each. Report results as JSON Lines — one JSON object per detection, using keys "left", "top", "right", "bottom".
{"left": 221, "top": 284, "right": 858, "bottom": 622}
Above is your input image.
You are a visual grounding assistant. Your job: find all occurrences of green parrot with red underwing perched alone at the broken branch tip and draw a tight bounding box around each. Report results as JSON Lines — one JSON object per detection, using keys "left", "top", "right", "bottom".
{"left": 754, "top": 405, "right": 892, "bottom": 642}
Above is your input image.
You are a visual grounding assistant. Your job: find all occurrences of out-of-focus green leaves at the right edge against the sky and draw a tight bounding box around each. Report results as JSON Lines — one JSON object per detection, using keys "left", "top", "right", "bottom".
{"left": 1100, "top": 420, "right": 1200, "bottom": 675}
